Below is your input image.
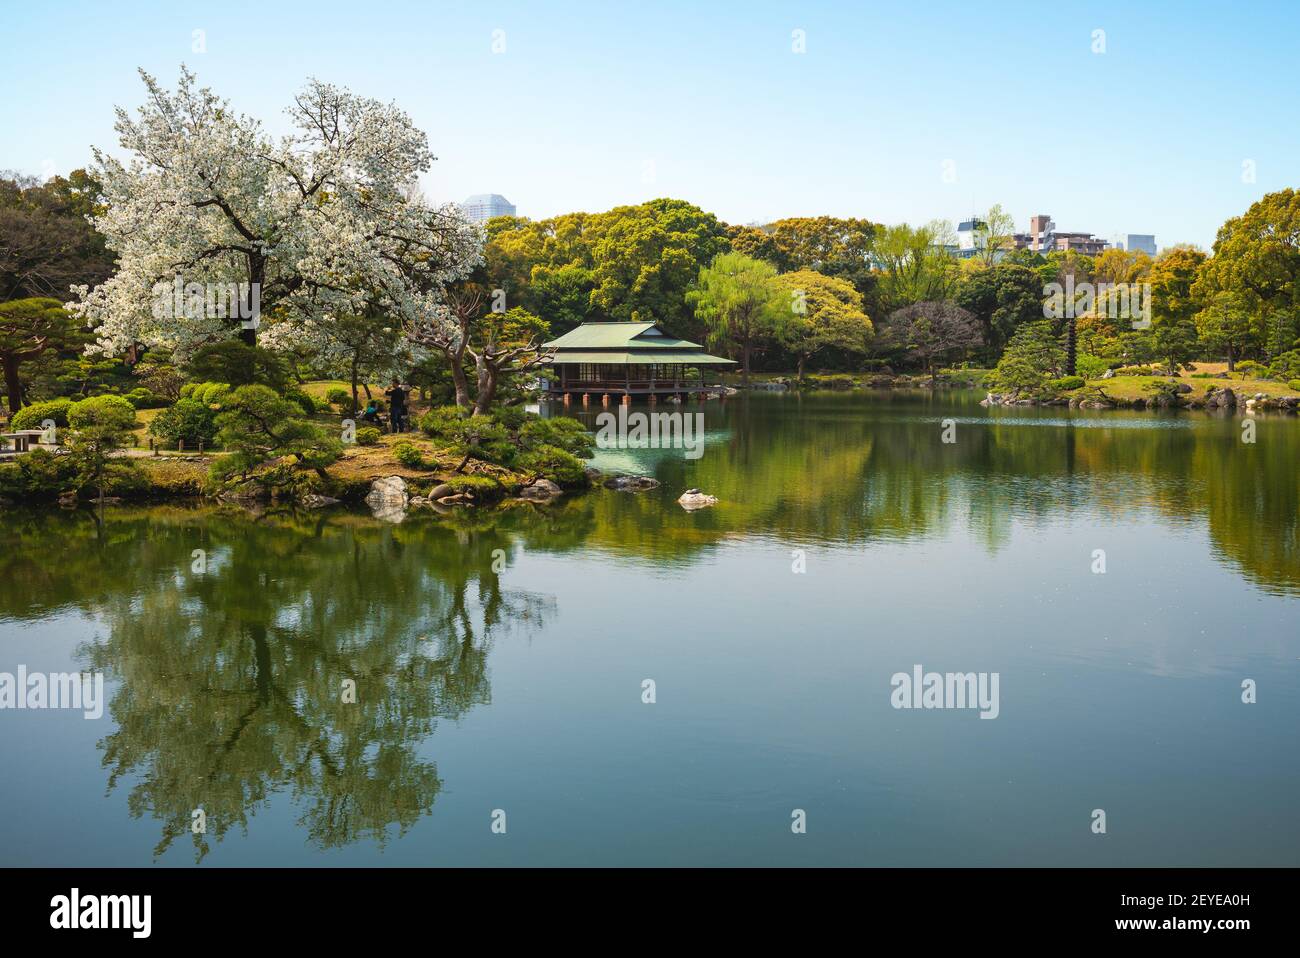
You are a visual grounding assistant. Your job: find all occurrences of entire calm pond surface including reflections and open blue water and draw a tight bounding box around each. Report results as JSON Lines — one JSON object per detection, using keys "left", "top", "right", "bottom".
{"left": 0, "top": 394, "right": 1300, "bottom": 866}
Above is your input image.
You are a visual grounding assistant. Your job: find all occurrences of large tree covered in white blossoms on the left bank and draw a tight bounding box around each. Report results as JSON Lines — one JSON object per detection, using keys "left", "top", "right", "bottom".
{"left": 69, "top": 66, "right": 482, "bottom": 360}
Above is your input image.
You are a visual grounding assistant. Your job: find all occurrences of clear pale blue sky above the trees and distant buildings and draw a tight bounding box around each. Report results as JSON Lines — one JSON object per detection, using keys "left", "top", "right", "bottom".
{"left": 0, "top": 0, "right": 1300, "bottom": 248}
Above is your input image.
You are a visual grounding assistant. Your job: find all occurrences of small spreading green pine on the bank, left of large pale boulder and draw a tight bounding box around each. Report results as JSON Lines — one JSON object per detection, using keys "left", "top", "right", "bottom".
{"left": 211, "top": 385, "right": 343, "bottom": 486}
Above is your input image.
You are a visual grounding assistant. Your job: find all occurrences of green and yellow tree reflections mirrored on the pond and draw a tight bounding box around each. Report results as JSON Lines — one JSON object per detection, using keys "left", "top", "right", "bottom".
{"left": 0, "top": 395, "right": 1300, "bottom": 861}
